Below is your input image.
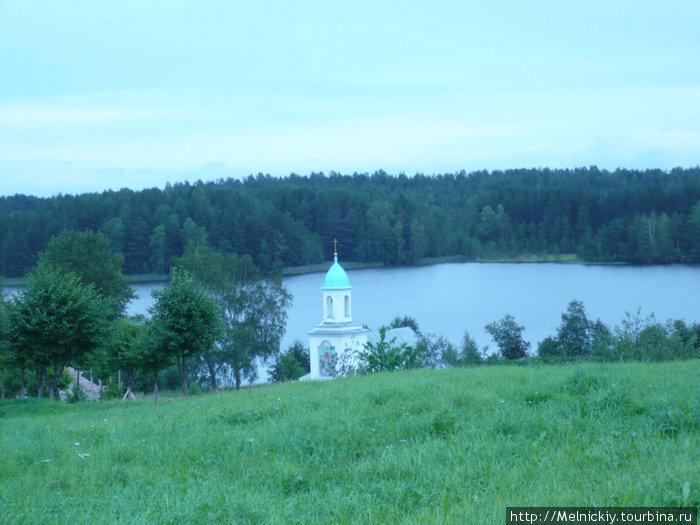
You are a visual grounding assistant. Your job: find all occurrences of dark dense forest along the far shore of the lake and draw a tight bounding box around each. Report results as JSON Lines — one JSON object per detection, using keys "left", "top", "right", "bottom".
{"left": 0, "top": 167, "right": 700, "bottom": 277}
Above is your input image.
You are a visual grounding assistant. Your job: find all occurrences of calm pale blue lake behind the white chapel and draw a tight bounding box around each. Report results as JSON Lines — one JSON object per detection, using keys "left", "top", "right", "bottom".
{"left": 129, "top": 263, "right": 700, "bottom": 351}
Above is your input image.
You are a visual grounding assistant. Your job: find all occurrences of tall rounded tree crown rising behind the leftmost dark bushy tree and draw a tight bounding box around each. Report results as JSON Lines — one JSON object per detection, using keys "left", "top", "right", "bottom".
{"left": 39, "top": 230, "right": 134, "bottom": 318}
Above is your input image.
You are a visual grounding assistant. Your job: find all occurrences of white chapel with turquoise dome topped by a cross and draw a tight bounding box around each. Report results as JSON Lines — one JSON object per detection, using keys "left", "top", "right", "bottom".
{"left": 307, "top": 244, "right": 370, "bottom": 379}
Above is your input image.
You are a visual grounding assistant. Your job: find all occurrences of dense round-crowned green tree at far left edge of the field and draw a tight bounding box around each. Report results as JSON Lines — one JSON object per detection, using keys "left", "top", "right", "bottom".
{"left": 11, "top": 264, "right": 107, "bottom": 399}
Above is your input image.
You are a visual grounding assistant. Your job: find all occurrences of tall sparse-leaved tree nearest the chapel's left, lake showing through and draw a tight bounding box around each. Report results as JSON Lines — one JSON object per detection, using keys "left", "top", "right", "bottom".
{"left": 178, "top": 243, "right": 291, "bottom": 389}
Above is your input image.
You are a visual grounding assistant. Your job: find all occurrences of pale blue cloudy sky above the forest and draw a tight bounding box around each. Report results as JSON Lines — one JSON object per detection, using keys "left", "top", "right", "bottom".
{"left": 0, "top": 0, "right": 700, "bottom": 196}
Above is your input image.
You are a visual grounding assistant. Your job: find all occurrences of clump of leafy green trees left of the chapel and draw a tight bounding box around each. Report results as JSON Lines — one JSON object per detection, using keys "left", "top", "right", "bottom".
{"left": 0, "top": 231, "right": 291, "bottom": 399}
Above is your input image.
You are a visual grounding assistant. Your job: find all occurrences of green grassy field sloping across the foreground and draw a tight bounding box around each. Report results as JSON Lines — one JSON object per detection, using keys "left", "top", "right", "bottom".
{"left": 0, "top": 361, "right": 700, "bottom": 524}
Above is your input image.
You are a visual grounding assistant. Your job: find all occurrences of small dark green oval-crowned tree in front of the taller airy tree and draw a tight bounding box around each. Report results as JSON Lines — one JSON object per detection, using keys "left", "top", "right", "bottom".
{"left": 151, "top": 267, "right": 220, "bottom": 397}
